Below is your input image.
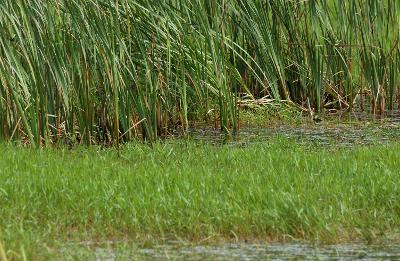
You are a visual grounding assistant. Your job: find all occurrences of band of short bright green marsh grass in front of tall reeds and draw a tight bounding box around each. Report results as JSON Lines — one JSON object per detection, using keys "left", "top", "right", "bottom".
{"left": 0, "top": 138, "right": 400, "bottom": 260}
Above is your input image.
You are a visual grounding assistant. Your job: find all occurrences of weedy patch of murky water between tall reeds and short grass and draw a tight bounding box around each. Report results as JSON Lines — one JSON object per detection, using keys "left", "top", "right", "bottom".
{"left": 189, "top": 118, "right": 400, "bottom": 147}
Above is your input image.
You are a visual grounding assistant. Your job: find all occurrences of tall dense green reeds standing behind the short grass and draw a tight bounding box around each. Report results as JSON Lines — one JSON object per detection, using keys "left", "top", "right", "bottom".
{"left": 0, "top": 0, "right": 400, "bottom": 145}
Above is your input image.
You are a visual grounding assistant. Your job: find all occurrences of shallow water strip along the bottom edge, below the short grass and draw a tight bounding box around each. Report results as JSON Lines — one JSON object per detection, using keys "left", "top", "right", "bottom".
{"left": 96, "top": 243, "right": 400, "bottom": 260}
